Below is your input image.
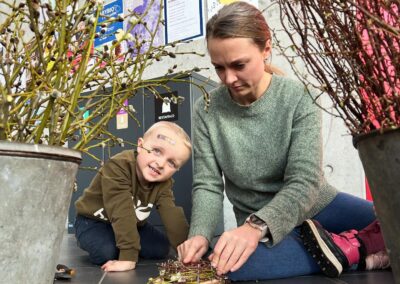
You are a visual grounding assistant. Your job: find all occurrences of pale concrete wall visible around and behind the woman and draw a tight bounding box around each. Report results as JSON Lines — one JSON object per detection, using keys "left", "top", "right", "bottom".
{"left": 145, "top": 0, "right": 365, "bottom": 229}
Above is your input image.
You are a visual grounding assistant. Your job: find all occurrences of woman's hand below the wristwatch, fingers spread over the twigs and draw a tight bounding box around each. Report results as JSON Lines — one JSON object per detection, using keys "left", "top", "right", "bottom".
{"left": 209, "top": 224, "right": 262, "bottom": 275}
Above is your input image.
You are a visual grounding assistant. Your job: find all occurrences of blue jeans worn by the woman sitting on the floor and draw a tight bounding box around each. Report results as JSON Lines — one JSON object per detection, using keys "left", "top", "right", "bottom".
{"left": 228, "top": 193, "right": 376, "bottom": 281}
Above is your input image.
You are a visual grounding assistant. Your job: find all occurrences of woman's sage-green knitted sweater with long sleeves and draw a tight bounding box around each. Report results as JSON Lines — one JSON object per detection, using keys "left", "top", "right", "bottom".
{"left": 189, "top": 75, "right": 337, "bottom": 245}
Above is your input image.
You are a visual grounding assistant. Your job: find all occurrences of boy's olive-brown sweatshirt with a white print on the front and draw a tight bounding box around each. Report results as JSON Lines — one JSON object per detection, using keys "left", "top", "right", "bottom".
{"left": 75, "top": 150, "right": 189, "bottom": 261}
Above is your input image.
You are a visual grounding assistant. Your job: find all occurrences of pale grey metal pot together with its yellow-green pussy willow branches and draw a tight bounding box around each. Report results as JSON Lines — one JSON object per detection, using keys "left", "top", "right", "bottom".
{"left": 0, "top": 0, "right": 202, "bottom": 284}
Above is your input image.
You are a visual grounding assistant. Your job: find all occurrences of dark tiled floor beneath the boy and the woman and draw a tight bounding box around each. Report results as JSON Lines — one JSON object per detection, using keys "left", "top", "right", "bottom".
{"left": 54, "top": 234, "right": 394, "bottom": 284}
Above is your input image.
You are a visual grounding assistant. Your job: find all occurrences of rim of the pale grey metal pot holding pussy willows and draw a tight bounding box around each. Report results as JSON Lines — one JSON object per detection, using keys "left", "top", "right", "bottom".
{"left": 0, "top": 141, "right": 82, "bottom": 164}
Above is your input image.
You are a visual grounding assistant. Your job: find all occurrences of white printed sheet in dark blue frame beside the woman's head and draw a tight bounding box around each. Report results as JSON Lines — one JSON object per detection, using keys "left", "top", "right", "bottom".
{"left": 164, "top": 0, "right": 204, "bottom": 43}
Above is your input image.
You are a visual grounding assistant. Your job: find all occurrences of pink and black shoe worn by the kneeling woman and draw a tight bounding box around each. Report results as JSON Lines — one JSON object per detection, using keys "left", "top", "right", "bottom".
{"left": 301, "top": 220, "right": 361, "bottom": 277}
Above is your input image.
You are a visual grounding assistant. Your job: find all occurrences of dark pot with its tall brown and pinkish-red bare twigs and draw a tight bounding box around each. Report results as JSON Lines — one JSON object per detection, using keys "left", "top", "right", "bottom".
{"left": 277, "top": 0, "right": 400, "bottom": 283}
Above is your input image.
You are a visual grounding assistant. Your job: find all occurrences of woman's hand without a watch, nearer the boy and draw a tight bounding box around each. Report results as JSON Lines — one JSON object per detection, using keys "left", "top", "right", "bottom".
{"left": 177, "top": 236, "right": 208, "bottom": 263}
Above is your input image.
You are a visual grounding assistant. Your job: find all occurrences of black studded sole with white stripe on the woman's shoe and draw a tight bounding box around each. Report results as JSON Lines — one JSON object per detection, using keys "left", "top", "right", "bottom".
{"left": 302, "top": 220, "right": 343, "bottom": 278}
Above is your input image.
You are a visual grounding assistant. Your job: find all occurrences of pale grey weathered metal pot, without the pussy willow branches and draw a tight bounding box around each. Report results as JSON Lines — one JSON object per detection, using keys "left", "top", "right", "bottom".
{"left": 0, "top": 142, "right": 81, "bottom": 284}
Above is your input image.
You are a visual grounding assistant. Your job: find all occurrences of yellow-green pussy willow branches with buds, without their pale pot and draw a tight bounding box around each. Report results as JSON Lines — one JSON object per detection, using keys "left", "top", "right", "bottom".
{"left": 0, "top": 0, "right": 206, "bottom": 151}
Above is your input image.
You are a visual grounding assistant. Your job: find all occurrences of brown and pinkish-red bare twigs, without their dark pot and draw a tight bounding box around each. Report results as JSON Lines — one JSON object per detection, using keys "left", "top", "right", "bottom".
{"left": 277, "top": 0, "right": 400, "bottom": 135}
